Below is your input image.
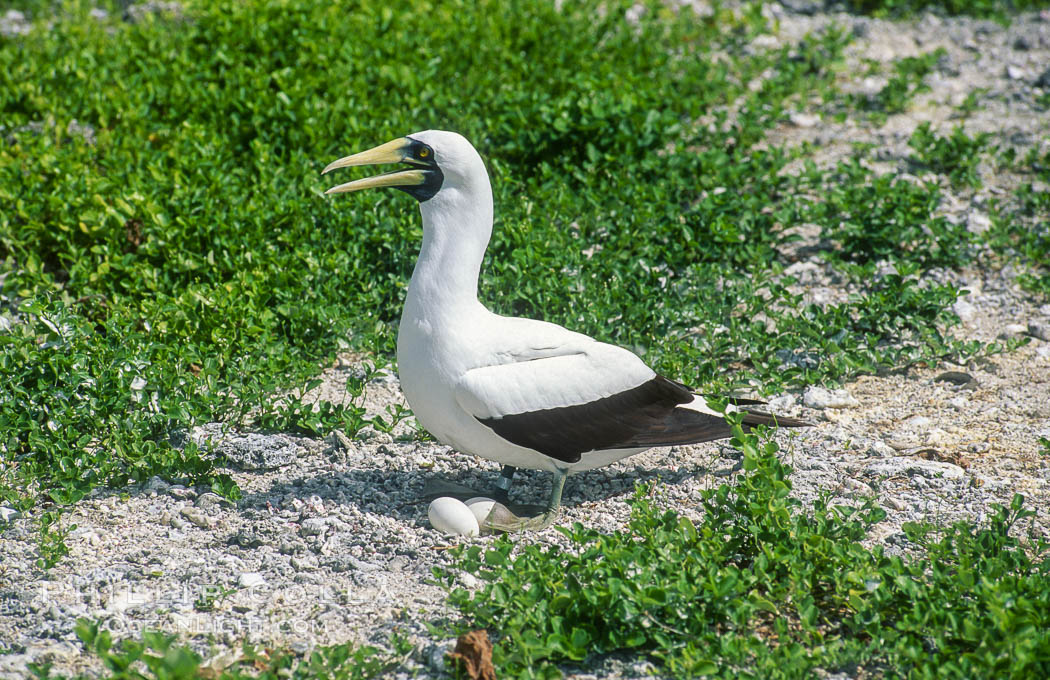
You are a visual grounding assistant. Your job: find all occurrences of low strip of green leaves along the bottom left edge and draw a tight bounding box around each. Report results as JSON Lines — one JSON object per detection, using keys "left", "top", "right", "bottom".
{"left": 30, "top": 619, "right": 410, "bottom": 680}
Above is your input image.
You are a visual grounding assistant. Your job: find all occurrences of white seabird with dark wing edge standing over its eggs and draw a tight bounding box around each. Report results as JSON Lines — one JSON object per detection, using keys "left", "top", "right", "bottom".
{"left": 323, "top": 130, "right": 806, "bottom": 528}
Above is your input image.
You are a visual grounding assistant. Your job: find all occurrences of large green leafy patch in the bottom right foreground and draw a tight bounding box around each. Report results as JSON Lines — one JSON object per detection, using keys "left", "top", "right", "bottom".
{"left": 436, "top": 426, "right": 1050, "bottom": 678}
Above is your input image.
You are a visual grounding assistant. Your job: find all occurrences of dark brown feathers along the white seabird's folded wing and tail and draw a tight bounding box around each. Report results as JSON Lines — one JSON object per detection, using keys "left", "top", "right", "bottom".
{"left": 478, "top": 376, "right": 809, "bottom": 463}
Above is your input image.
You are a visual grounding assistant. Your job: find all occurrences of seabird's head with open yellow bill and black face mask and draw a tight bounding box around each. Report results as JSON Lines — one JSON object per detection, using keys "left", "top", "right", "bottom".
{"left": 321, "top": 130, "right": 488, "bottom": 203}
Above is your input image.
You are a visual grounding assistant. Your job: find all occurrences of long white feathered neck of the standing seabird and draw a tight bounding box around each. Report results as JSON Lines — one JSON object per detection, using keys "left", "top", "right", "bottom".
{"left": 404, "top": 178, "right": 492, "bottom": 322}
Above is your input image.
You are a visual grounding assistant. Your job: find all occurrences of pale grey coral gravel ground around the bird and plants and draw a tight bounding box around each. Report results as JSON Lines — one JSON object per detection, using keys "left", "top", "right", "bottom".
{"left": 0, "top": 3, "right": 1050, "bottom": 678}
